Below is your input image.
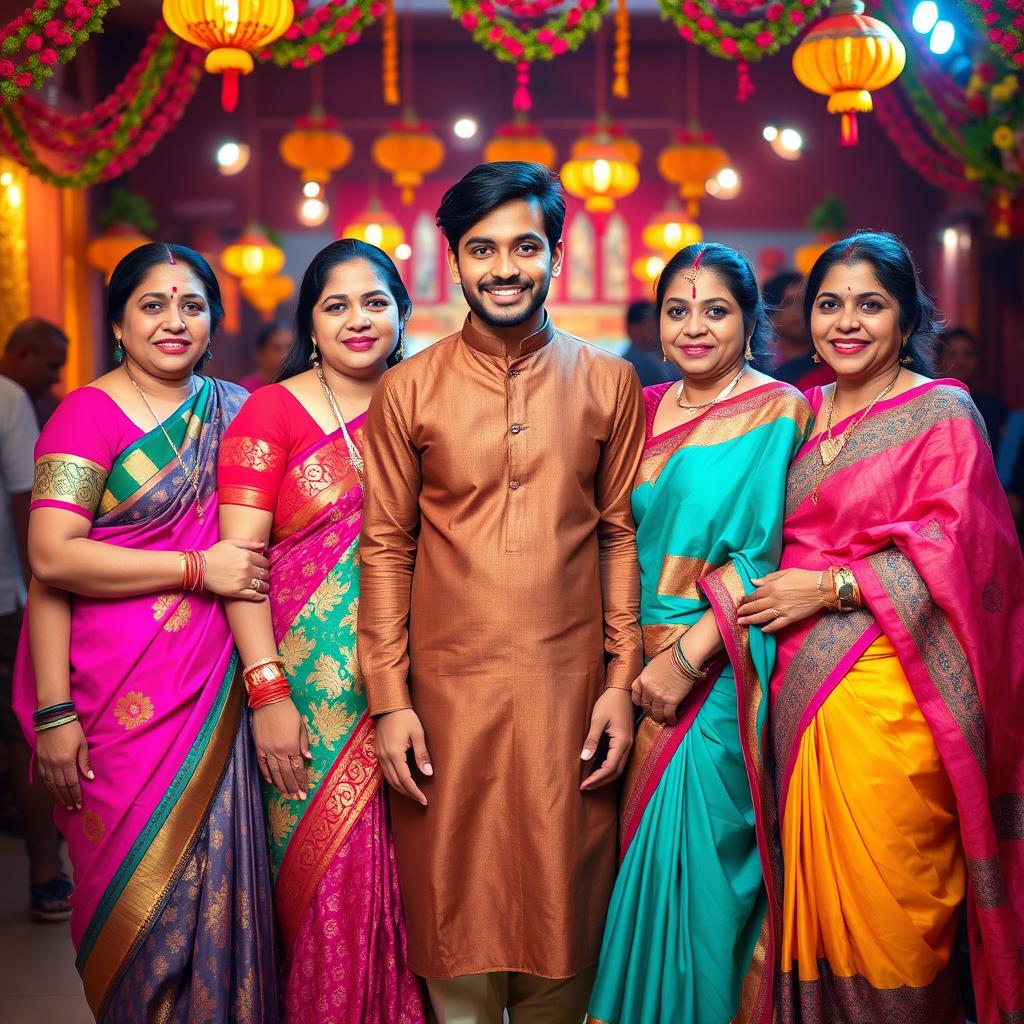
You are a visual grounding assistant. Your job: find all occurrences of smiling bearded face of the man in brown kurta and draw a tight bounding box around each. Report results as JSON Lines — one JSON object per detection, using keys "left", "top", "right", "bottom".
{"left": 447, "top": 199, "right": 562, "bottom": 328}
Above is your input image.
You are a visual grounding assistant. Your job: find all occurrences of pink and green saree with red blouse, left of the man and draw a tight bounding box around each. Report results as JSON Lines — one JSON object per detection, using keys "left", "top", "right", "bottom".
{"left": 219, "top": 384, "right": 424, "bottom": 1024}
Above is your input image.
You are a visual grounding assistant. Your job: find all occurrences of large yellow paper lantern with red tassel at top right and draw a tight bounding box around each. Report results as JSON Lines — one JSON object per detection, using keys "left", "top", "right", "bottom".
{"left": 793, "top": 0, "right": 906, "bottom": 145}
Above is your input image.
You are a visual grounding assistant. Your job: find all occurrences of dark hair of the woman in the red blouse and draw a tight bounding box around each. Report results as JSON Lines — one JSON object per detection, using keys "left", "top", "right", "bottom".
{"left": 275, "top": 239, "right": 413, "bottom": 381}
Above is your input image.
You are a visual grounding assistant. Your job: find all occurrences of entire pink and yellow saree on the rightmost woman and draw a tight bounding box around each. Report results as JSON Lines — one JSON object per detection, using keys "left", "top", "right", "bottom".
{"left": 771, "top": 381, "right": 1024, "bottom": 1024}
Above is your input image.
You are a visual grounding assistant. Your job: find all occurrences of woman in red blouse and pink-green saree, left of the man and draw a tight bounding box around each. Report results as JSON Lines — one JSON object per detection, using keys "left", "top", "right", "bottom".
{"left": 219, "top": 239, "right": 424, "bottom": 1024}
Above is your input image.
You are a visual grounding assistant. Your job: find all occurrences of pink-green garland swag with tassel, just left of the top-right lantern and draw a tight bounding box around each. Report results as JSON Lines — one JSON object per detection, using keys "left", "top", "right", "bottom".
{"left": 658, "top": 0, "right": 824, "bottom": 62}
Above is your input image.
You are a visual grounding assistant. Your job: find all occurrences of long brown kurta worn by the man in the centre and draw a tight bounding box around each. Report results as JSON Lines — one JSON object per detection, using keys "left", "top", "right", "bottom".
{"left": 358, "top": 321, "right": 643, "bottom": 978}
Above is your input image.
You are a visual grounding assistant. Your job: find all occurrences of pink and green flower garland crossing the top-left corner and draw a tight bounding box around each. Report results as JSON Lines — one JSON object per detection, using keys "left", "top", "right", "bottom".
{"left": 0, "top": 0, "right": 118, "bottom": 103}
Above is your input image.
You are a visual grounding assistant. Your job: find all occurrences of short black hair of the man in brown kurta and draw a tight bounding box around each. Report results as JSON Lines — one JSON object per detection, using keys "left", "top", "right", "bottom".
{"left": 437, "top": 160, "right": 565, "bottom": 249}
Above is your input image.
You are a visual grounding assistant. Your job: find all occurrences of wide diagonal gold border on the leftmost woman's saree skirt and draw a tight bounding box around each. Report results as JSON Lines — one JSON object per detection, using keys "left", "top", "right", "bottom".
{"left": 82, "top": 676, "right": 242, "bottom": 1020}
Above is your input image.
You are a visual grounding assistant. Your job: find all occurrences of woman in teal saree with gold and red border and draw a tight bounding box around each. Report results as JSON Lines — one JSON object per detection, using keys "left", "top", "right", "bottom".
{"left": 590, "top": 244, "right": 810, "bottom": 1024}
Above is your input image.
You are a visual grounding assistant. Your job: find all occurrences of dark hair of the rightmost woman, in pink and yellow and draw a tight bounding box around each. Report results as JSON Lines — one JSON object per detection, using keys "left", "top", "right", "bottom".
{"left": 804, "top": 231, "right": 940, "bottom": 377}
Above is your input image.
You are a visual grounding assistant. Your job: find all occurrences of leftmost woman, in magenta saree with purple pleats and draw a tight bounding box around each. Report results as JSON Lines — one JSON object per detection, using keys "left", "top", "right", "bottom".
{"left": 14, "top": 243, "right": 278, "bottom": 1024}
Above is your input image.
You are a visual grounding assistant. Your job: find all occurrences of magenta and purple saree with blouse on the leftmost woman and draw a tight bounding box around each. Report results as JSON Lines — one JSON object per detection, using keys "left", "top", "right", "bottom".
{"left": 14, "top": 379, "right": 278, "bottom": 1024}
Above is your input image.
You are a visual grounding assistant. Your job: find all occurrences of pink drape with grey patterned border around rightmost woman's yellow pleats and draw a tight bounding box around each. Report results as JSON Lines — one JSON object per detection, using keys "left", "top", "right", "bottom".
{"left": 772, "top": 381, "right": 1024, "bottom": 1024}
